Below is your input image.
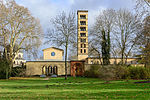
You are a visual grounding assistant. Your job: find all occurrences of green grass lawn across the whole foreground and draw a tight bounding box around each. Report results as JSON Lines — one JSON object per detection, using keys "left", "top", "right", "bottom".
{"left": 0, "top": 77, "right": 150, "bottom": 100}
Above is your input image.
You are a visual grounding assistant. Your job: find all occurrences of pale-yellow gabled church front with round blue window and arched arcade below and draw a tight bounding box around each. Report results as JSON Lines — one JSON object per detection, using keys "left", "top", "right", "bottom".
{"left": 26, "top": 47, "right": 70, "bottom": 76}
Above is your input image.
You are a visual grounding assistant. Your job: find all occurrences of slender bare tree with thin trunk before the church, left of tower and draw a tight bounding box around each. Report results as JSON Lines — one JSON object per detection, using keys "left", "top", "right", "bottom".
{"left": 46, "top": 12, "right": 76, "bottom": 79}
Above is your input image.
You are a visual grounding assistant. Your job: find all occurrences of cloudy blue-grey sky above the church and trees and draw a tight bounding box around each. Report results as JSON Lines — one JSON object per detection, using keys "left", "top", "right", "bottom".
{"left": 15, "top": 0, "right": 135, "bottom": 59}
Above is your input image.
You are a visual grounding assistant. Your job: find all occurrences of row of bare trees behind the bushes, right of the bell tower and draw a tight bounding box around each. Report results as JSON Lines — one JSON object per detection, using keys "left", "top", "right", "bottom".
{"left": 89, "top": 7, "right": 150, "bottom": 66}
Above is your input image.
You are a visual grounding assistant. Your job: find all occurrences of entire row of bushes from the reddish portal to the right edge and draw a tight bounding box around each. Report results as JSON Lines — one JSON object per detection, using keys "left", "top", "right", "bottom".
{"left": 84, "top": 65, "right": 150, "bottom": 81}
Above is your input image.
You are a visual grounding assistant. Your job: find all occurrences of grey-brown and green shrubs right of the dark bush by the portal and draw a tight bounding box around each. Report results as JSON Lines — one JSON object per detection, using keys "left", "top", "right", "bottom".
{"left": 99, "top": 65, "right": 150, "bottom": 81}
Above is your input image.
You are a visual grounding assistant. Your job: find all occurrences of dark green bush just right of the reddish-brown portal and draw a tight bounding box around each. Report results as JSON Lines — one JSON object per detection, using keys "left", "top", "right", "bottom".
{"left": 84, "top": 65, "right": 101, "bottom": 78}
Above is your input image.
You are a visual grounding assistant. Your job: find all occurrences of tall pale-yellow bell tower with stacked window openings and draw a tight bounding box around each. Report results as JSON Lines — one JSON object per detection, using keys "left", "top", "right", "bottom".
{"left": 77, "top": 10, "right": 88, "bottom": 60}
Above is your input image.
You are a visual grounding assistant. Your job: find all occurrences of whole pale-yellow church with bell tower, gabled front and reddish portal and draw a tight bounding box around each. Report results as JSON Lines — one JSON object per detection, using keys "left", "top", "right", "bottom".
{"left": 26, "top": 10, "right": 136, "bottom": 76}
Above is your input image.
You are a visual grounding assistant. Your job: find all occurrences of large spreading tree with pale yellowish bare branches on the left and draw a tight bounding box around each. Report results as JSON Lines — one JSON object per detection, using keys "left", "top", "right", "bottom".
{"left": 0, "top": 0, "right": 42, "bottom": 78}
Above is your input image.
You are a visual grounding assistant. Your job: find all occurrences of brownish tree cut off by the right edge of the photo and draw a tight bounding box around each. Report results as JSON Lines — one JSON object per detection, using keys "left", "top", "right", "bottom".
{"left": 135, "top": 0, "right": 150, "bottom": 67}
